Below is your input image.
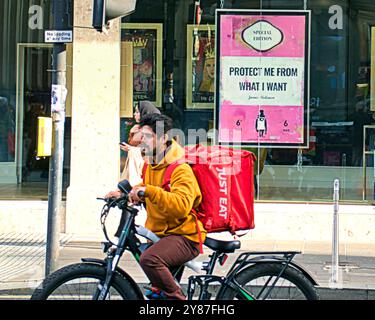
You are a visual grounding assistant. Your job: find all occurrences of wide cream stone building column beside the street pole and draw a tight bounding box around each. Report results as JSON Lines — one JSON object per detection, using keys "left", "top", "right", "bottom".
{"left": 66, "top": 0, "right": 120, "bottom": 235}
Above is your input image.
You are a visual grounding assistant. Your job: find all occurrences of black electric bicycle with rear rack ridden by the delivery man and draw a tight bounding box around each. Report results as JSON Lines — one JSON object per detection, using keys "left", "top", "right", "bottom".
{"left": 31, "top": 180, "right": 319, "bottom": 300}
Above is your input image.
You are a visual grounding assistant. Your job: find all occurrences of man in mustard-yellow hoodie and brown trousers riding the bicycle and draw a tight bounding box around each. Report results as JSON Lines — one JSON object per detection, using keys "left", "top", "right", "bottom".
{"left": 106, "top": 114, "right": 206, "bottom": 300}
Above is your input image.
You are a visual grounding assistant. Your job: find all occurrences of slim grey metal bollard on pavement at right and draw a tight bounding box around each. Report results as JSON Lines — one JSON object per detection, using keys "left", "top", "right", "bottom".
{"left": 331, "top": 179, "right": 340, "bottom": 283}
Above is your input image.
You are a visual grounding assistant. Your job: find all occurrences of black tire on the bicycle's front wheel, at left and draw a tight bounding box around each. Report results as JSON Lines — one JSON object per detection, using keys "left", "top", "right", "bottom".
{"left": 31, "top": 263, "right": 139, "bottom": 300}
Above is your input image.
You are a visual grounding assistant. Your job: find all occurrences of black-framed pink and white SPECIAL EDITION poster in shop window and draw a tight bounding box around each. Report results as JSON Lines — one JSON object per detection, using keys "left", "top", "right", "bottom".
{"left": 216, "top": 10, "right": 309, "bottom": 147}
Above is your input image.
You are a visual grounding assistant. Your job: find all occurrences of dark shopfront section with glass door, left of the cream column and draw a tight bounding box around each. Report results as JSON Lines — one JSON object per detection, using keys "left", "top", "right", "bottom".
{"left": 0, "top": 1, "right": 71, "bottom": 199}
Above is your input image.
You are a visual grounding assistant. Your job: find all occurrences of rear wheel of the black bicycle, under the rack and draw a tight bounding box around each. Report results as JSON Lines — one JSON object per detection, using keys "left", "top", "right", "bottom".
{"left": 219, "top": 263, "right": 319, "bottom": 300}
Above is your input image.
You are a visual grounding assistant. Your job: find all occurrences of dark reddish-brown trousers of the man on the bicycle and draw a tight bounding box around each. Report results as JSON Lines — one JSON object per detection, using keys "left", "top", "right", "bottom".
{"left": 140, "top": 235, "right": 199, "bottom": 300}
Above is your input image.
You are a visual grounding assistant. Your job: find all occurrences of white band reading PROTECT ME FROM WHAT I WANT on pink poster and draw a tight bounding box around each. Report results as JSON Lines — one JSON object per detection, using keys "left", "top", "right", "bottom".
{"left": 220, "top": 57, "right": 304, "bottom": 106}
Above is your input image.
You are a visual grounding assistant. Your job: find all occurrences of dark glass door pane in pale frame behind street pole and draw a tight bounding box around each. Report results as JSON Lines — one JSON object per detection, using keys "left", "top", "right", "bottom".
{"left": 17, "top": 44, "right": 52, "bottom": 184}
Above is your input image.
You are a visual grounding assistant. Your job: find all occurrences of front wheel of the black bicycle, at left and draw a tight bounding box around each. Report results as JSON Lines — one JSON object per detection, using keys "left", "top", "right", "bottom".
{"left": 31, "top": 263, "right": 139, "bottom": 300}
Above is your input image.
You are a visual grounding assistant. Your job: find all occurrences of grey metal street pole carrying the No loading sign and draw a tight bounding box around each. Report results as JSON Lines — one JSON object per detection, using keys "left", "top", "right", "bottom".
{"left": 45, "top": 0, "right": 67, "bottom": 276}
